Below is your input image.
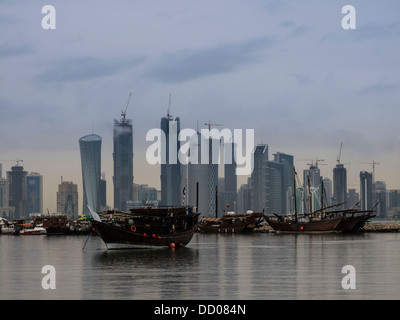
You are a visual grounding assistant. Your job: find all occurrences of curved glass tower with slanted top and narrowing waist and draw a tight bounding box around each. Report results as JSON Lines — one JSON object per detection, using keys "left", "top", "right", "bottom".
{"left": 79, "top": 134, "right": 102, "bottom": 214}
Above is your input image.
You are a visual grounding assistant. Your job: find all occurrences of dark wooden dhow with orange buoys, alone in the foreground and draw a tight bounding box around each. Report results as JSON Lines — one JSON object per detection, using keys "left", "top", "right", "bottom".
{"left": 89, "top": 206, "right": 200, "bottom": 249}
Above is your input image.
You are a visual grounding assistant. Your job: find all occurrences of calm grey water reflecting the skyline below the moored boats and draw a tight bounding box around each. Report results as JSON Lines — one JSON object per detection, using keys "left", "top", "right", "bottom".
{"left": 0, "top": 233, "right": 400, "bottom": 300}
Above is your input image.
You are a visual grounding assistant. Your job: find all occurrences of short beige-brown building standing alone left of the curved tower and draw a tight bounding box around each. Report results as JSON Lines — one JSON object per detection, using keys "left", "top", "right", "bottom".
{"left": 57, "top": 181, "right": 78, "bottom": 219}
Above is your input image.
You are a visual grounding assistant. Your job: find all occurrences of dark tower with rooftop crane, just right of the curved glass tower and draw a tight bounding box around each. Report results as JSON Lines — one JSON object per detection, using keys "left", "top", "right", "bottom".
{"left": 113, "top": 112, "right": 133, "bottom": 211}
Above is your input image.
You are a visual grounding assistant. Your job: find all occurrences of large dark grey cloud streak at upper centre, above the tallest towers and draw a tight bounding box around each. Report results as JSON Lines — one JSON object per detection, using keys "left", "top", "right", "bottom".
{"left": 145, "top": 36, "right": 276, "bottom": 82}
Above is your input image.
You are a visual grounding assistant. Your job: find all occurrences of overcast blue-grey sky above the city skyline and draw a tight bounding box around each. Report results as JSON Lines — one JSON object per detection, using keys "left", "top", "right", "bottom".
{"left": 0, "top": 0, "right": 400, "bottom": 212}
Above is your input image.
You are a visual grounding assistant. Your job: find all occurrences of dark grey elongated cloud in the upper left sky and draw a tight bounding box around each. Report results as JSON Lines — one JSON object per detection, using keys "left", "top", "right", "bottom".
{"left": 35, "top": 56, "right": 145, "bottom": 82}
